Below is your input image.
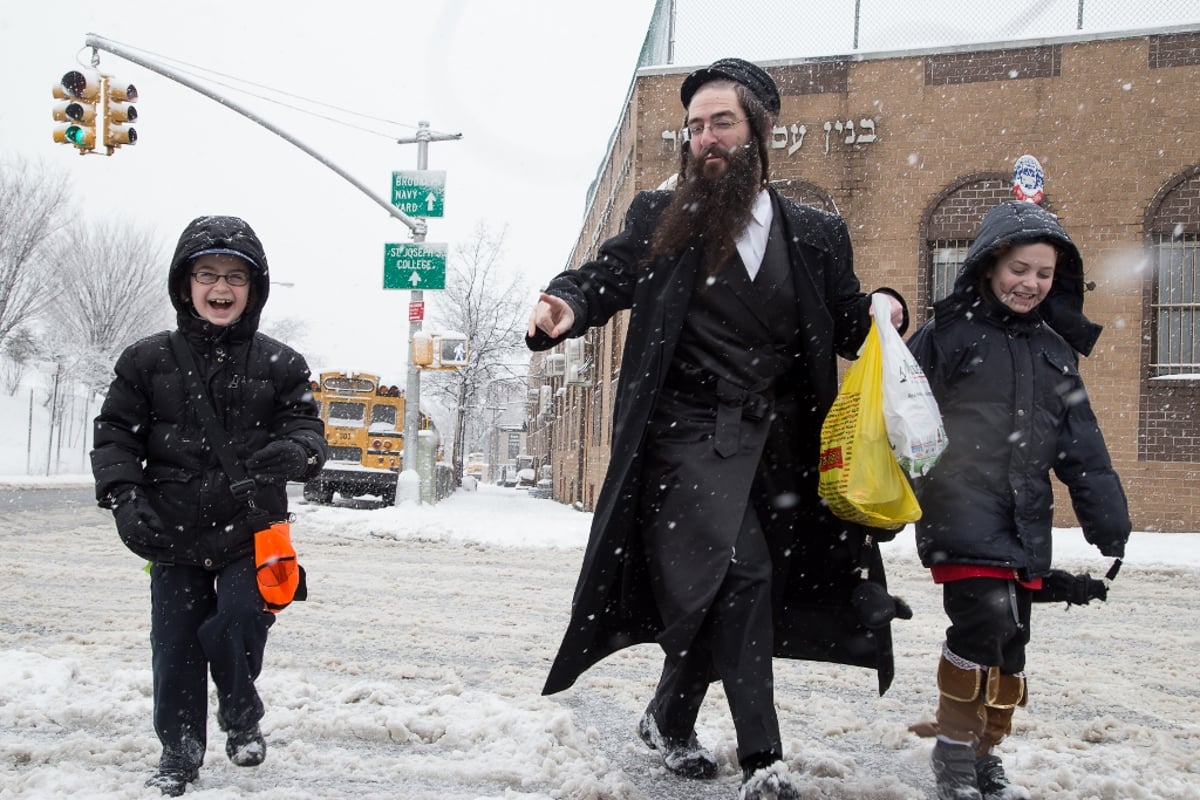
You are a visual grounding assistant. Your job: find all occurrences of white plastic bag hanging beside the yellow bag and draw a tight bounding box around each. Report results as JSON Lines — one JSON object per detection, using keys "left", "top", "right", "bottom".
{"left": 871, "top": 294, "right": 949, "bottom": 477}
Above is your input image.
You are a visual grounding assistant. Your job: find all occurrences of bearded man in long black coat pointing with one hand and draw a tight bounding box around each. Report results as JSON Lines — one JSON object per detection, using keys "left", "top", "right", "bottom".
{"left": 526, "top": 59, "right": 907, "bottom": 800}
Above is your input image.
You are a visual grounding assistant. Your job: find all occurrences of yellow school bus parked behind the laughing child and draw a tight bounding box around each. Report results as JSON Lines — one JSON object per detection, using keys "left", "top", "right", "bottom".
{"left": 304, "top": 372, "right": 428, "bottom": 505}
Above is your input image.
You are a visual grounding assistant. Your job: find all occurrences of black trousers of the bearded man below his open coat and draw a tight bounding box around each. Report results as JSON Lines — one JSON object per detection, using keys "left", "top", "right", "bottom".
{"left": 650, "top": 504, "right": 782, "bottom": 763}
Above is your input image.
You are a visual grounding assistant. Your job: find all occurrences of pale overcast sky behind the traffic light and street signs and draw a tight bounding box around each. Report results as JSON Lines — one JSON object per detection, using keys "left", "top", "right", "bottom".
{"left": 0, "top": 0, "right": 654, "bottom": 373}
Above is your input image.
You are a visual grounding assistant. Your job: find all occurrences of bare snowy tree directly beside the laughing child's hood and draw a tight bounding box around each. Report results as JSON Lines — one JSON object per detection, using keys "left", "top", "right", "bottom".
{"left": 46, "top": 217, "right": 172, "bottom": 389}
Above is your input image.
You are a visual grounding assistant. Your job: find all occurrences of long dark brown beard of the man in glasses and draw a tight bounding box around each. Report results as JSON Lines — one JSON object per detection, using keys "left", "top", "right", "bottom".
{"left": 650, "top": 142, "right": 762, "bottom": 275}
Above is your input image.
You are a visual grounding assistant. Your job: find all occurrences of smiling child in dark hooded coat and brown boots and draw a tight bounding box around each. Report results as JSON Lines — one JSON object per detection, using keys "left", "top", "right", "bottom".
{"left": 908, "top": 201, "right": 1130, "bottom": 800}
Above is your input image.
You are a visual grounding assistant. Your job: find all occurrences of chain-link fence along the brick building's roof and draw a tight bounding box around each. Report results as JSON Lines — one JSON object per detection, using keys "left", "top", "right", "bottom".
{"left": 638, "top": 0, "right": 1200, "bottom": 67}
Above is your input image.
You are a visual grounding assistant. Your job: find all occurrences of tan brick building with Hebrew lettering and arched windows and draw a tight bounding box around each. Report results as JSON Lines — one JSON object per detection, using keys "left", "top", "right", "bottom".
{"left": 528, "top": 26, "right": 1200, "bottom": 531}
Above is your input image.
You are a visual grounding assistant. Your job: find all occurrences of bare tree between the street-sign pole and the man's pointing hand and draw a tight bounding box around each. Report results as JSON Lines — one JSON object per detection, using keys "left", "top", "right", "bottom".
{"left": 430, "top": 222, "right": 529, "bottom": 477}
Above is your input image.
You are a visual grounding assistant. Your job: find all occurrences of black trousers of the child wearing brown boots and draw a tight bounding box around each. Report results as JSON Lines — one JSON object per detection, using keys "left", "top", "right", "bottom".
{"left": 942, "top": 578, "right": 1033, "bottom": 675}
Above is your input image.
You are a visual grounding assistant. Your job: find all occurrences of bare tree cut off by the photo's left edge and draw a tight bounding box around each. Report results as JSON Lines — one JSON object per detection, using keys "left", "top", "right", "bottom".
{"left": 0, "top": 158, "right": 71, "bottom": 343}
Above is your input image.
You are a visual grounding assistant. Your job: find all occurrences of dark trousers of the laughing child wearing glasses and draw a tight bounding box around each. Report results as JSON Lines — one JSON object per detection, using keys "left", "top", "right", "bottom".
{"left": 150, "top": 557, "right": 275, "bottom": 769}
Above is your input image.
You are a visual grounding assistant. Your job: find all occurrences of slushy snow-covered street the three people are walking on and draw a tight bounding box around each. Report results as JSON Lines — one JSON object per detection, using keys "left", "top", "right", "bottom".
{"left": 0, "top": 476, "right": 1200, "bottom": 800}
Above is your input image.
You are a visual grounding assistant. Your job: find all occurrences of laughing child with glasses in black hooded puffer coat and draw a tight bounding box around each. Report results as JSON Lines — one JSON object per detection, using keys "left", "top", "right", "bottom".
{"left": 91, "top": 216, "right": 326, "bottom": 796}
